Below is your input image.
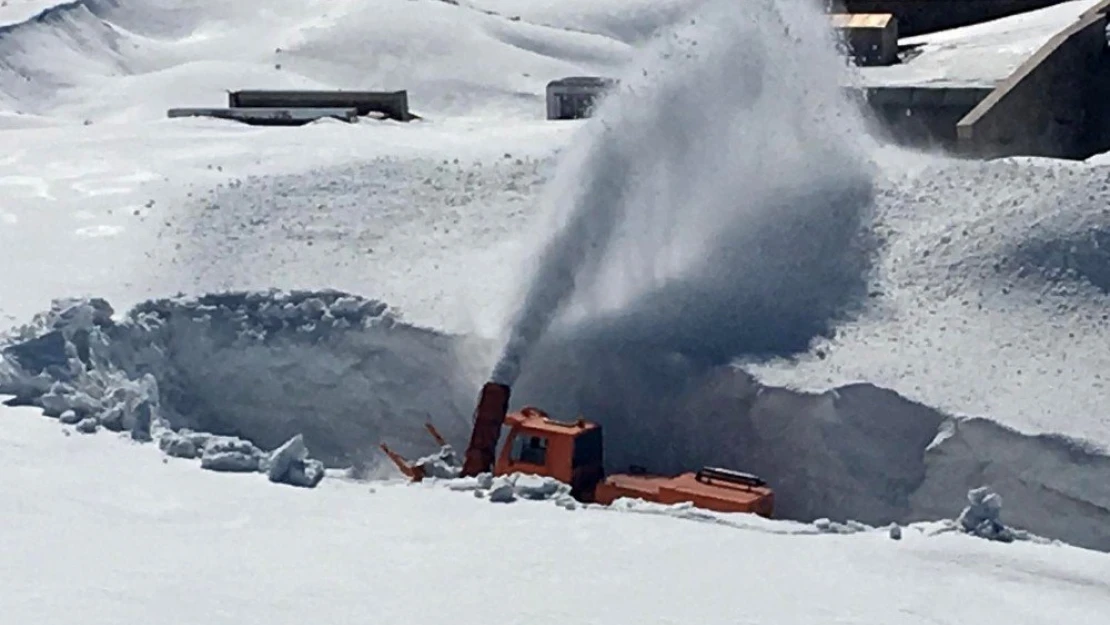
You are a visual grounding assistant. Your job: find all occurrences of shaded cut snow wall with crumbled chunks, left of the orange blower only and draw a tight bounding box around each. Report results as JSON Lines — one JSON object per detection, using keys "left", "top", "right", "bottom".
{"left": 0, "top": 292, "right": 486, "bottom": 472}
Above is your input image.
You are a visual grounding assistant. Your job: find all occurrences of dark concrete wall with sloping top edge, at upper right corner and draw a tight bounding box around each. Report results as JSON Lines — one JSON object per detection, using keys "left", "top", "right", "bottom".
{"left": 957, "top": 0, "right": 1110, "bottom": 158}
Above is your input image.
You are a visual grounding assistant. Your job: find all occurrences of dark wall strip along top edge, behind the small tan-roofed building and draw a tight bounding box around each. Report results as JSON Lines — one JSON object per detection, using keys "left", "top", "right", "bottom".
{"left": 831, "top": 0, "right": 1064, "bottom": 37}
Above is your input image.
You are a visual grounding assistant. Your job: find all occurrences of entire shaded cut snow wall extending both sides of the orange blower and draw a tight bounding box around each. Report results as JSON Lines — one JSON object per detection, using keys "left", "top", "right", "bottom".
{"left": 0, "top": 291, "right": 1110, "bottom": 551}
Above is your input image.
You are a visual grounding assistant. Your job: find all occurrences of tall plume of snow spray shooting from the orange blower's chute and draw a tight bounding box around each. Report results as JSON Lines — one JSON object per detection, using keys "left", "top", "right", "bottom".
{"left": 492, "top": 0, "right": 871, "bottom": 395}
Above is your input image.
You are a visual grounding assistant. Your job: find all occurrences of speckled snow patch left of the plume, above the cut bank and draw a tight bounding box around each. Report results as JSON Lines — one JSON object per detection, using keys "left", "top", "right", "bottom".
{"left": 159, "top": 153, "right": 552, "bottom": 331}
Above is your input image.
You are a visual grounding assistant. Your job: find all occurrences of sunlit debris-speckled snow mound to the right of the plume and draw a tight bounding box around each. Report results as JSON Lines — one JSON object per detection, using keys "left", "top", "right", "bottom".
{"left": 744, "top": 155, "right": 1110, "bottom": 444}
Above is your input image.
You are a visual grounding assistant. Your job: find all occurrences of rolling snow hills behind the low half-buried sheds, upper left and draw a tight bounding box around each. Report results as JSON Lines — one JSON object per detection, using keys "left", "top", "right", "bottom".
{"left": 0, "top": 0, "right": 629, "bottom": 119}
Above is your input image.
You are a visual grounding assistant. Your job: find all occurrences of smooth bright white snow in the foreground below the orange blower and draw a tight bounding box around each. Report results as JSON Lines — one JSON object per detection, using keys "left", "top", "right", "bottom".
{"left": 0, "top": 401, "right": 1110, "bottom": 625}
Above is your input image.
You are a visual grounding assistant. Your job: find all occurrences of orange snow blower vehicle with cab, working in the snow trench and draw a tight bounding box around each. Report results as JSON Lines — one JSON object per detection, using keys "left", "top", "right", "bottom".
{"left": 381, "top": 382, "right": 775, "bottom": 517}
